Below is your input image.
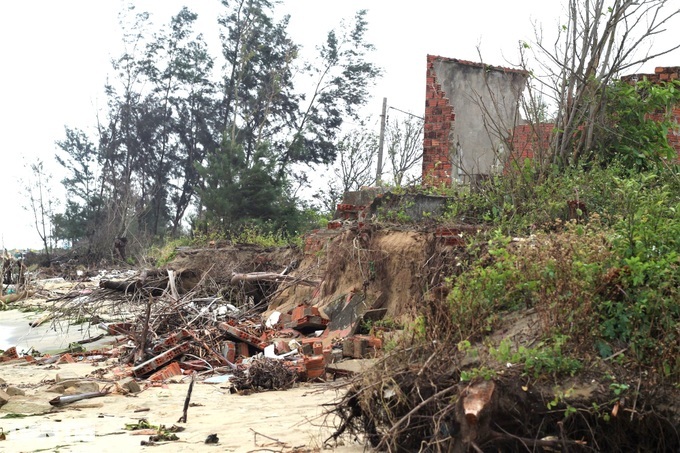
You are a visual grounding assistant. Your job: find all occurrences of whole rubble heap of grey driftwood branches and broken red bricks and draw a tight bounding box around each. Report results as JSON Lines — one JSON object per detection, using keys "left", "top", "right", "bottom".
{"left": 0, "top": 270, "right": 385, "bottom": 391}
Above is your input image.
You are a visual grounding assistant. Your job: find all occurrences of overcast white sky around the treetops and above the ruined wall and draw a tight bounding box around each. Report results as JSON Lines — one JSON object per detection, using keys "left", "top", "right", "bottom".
{"left": 0, "top": 0, "right": 680, "bottom": 248}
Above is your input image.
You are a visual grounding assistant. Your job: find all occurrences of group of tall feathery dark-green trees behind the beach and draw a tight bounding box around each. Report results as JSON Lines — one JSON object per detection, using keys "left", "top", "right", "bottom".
{"left": 52, "top": 0, "right": 396, "bottom": 256}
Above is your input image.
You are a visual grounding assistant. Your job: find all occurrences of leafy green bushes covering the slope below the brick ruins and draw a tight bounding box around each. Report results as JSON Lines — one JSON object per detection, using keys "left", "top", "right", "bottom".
{"left": 436, "top": 161, "right": 680, "bottom": 379}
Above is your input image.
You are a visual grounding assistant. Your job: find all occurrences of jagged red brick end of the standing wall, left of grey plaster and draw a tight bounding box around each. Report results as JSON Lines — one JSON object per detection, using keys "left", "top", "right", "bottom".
{"left": 423, "top": 55, "right": 456, "bottom": 186}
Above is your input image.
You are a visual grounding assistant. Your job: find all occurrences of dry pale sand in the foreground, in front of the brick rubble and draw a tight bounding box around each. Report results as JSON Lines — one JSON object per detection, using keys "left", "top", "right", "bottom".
{"left": 0, "top": 360, "right": 363, "bottom": 452}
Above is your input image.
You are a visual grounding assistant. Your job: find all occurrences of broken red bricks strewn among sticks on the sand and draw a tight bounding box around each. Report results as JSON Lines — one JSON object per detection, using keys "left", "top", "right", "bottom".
{"left": 5, "top": 305, "right": 382, "bottom": 385}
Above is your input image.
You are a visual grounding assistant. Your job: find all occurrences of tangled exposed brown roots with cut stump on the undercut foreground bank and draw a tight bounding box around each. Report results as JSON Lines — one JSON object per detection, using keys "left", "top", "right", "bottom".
{"left": 327, "top": 347, "right": 680, "bottom": 453}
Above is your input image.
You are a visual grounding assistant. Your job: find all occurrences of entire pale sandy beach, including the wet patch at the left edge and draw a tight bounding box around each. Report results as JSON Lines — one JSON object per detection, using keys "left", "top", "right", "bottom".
{"left": 0, "top": 270, "right": 378, "bottom": 452}
